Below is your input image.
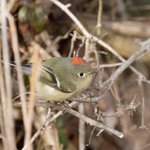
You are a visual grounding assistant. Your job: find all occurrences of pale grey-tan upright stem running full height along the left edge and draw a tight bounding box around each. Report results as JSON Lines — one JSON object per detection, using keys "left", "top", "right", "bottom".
{"left": 1, "top": 0, "right": 15, "bottom": 150}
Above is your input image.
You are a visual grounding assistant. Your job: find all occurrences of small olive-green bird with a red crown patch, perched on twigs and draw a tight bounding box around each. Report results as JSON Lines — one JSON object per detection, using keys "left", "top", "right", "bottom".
{"left": 22, "top": 57, "right": 92, "bottom": 101}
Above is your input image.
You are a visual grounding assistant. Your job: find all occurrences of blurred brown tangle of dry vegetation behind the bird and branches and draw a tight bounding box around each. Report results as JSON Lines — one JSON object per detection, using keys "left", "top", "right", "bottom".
{"left": 0, "top": 0, "right": 150, "bottom": 150}
